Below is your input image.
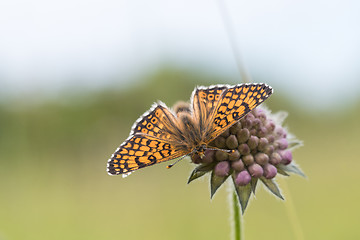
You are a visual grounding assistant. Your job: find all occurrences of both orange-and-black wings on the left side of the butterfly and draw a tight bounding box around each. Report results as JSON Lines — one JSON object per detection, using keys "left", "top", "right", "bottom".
{"left": 107, "top": 104, "right": 189, "bottom": 175}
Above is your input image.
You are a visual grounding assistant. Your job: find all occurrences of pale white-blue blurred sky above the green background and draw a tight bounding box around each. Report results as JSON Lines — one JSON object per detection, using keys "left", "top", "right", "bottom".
{"left": 0, "top": 0, "right": 360, "bottom": 106}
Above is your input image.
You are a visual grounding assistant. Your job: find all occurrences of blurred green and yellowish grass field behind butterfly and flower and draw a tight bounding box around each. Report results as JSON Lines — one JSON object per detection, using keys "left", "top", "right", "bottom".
{"left": 0, "top": 68, "right": 360, "bottom": 240}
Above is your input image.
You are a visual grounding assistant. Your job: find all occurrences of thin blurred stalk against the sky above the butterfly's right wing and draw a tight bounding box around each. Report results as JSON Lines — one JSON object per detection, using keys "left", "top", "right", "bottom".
{"left": 217, "top": 0, "right": 252, "bottom": 83}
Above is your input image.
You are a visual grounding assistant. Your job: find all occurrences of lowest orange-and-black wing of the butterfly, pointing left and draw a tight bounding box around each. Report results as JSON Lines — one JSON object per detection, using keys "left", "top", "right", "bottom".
{"left": 107, "top": 134, "right": 189, "bottom": 175}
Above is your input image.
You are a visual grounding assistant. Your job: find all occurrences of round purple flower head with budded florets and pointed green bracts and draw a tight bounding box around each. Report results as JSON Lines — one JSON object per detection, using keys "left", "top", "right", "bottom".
{"left": 174, "top": 102, "right": 305, "bottom": 213}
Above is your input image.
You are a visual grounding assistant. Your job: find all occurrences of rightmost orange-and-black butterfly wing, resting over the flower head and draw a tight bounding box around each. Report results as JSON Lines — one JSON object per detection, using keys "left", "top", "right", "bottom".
{"left": 206, "top": 83, "right": 273, "bottom": 142}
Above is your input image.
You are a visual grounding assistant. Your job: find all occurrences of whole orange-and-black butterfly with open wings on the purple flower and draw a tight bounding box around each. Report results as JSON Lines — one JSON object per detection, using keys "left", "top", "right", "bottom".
{"left": 107, "top": 83, "right": 273, "bottom": 176}
